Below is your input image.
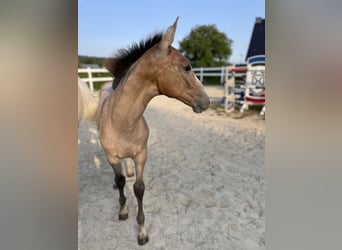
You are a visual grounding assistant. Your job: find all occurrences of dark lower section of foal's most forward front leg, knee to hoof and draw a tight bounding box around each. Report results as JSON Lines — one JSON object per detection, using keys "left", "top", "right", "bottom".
{"left": 134, "top": 178, "right": 149, "bottom": 245}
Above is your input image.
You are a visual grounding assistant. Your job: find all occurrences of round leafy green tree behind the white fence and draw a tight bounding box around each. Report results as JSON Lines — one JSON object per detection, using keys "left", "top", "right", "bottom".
{"left": 179, "top": 24, "right": 233, "bottom": 67}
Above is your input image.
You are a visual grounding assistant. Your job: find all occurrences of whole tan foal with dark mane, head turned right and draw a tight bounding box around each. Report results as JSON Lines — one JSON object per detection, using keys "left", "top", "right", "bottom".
{"left": 96, "top": 18, "right": 209, "bottom": 245}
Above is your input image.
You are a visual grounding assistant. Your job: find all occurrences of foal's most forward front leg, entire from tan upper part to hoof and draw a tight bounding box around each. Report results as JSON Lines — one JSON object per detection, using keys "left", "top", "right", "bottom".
{"left": 134, "top": 149, "right": 149, "bottom": 245}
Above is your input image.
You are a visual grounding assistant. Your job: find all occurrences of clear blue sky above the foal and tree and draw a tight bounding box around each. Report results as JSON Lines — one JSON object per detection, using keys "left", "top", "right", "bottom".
{"left": 78, "top": 0, "right": 265, "bottom": 63}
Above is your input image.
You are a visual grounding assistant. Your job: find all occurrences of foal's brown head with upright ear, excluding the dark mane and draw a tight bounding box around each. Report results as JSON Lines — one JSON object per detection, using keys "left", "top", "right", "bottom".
{"left": 146, "top": 18, "right": 210, "bottom": 113}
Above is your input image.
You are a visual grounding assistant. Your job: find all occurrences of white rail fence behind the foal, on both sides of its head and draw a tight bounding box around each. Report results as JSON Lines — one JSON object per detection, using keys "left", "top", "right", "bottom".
{"left": 78, "top": 67, "right": 243, "bottom": 91}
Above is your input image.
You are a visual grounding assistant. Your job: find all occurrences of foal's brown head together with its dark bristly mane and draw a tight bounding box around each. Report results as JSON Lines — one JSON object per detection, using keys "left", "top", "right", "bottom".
{"left": 106, "top": 17, "right": 210, "bottom": 113}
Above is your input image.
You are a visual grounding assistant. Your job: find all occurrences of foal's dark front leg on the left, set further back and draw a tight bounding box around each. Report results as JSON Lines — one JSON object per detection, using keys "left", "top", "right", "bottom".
{"left": 110, "top": 163, "right": 128, "bottom": 220}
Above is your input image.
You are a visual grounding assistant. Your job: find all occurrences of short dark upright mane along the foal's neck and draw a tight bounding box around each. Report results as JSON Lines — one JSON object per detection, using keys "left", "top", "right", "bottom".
{"left": 105, "top": 33, "right": 163, "bottom": 89}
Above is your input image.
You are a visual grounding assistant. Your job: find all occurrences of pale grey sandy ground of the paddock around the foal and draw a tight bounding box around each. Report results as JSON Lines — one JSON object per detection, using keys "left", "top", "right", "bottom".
{"left": 78, "top": 87, "right": 265, "bottom": 250}
